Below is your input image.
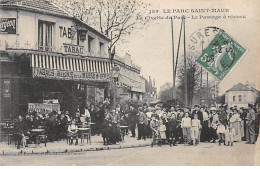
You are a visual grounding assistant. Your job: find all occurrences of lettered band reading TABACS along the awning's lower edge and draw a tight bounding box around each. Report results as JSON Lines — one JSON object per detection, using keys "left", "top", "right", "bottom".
{"left": 33, "top": 67, "right": 111, "bottom": 82}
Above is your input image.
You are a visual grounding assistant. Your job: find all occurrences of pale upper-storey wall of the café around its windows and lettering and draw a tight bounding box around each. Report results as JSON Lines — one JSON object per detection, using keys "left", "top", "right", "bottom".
{"left": 0, "top": 9, "right": 108, "bottom": 58}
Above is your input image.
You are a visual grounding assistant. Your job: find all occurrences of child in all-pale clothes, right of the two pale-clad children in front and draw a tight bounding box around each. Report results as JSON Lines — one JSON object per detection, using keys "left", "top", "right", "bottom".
{"left": 191, "top": 114, "right": 201, "bottom": 146}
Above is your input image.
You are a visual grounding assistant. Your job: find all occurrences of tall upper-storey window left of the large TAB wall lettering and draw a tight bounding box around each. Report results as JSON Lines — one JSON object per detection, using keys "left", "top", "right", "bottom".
{"left": 38, "top": 20, "right": 54, "bottom": 51}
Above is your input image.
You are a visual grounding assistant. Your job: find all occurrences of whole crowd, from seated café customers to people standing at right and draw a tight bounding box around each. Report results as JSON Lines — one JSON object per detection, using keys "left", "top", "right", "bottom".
{"left": 11, "top": 101, "right": 259, "bottom": 148}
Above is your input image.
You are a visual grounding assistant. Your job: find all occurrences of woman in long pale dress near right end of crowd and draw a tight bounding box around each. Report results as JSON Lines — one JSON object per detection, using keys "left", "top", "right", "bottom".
{"left": 230, "top": 109, "right": 243, "bottom": 141}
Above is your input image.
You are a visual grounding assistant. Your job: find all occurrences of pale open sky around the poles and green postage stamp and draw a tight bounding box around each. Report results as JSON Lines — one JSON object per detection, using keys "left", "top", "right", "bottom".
{"left": 119, "top": 0, "right": 260, "bottom": 94}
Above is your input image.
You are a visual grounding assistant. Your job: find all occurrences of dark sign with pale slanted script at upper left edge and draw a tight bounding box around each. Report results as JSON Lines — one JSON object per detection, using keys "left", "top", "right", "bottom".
{"left": 0, "top": 18, "right": 16, "bottom": 34}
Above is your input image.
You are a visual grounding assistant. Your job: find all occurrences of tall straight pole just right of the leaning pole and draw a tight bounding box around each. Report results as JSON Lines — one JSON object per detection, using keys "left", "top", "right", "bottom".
{"left": 182, "top": 15, "right": 188, "bottom": 107}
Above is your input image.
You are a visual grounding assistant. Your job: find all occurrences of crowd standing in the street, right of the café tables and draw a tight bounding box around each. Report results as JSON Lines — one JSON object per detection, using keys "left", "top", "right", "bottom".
{"left": 123, "top": 104, "right": 259, "bottom": 146}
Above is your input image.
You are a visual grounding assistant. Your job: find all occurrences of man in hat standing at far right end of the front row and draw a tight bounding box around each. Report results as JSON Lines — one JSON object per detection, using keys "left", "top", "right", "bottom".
{"left": 246, "top": 104, "right": 255, "bottom": 144}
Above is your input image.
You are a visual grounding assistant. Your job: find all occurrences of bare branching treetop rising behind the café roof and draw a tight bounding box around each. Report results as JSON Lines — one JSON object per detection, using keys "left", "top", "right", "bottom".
{"left": 57, "top": 0, "right": 150, "bottom": 56}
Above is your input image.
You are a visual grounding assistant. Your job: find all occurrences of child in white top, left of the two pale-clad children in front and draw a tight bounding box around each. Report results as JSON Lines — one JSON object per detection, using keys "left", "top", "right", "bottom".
{"left": 181, "top": 112, "right": 191, "bottom": 145}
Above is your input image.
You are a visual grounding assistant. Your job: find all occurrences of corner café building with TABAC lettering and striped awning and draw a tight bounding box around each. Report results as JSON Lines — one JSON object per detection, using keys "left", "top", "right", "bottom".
{"left": 0, "top": 0, "right": 113, "bottom": 120}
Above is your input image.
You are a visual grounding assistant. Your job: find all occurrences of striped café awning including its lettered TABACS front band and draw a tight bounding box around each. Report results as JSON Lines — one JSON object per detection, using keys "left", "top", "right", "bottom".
{"left": 31, "top": 54, "right": 112, "bottom": 81}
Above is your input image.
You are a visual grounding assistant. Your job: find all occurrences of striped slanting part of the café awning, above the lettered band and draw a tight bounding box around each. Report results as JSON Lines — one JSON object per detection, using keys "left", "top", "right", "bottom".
{"left": 31, "top": 54, "right": 112, "bottom": 73}
